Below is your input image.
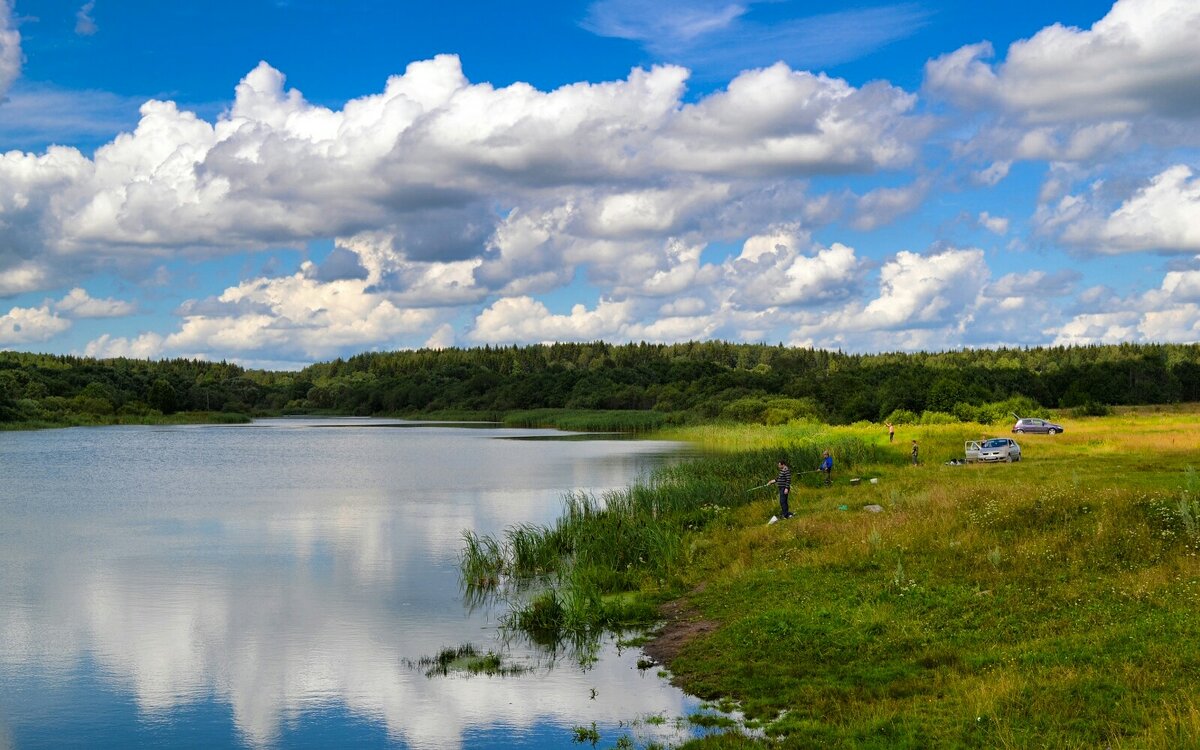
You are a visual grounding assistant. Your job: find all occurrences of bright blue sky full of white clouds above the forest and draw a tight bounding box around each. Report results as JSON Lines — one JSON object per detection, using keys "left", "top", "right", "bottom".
{"left": 0, "top": 0, "right": 1200, "bottom": 370}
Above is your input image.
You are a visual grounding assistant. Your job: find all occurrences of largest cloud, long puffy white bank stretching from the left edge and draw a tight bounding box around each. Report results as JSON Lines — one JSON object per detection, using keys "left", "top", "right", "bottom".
{"left": 0, "top": 55, "right": 928, "bottom": 301}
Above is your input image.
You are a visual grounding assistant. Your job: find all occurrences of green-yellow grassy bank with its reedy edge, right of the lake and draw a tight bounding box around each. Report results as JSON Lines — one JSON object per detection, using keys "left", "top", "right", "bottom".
{"left": 463, "top": 408, "right": 1200, "bottom": 748}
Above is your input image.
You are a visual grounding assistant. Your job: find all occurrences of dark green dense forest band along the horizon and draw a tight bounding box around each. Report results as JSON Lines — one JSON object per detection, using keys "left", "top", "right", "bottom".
{"left": 0, "top": 342, "right": 1200, "bottom": 424}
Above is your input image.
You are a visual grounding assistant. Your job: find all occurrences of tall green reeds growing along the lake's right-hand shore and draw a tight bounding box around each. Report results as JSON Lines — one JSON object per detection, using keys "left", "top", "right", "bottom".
{"left": 461, "top": 434, "right": 881, "bottom": 644}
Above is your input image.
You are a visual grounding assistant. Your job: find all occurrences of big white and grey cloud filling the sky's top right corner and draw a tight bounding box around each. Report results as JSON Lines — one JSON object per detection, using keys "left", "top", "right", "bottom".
{"left": 924, "top": 0, "right": 1200, "bottom": 166}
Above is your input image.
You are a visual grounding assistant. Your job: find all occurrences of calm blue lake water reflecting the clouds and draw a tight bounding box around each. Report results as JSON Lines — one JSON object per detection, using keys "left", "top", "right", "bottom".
{"left": 0, "top": 420, "right": 697, "bottom": 749}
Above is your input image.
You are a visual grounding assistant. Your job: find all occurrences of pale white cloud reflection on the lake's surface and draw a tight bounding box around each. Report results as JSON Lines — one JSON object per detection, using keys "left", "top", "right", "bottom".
{"left": 0, "top": 417, "right": 694, "bottom": 748}
